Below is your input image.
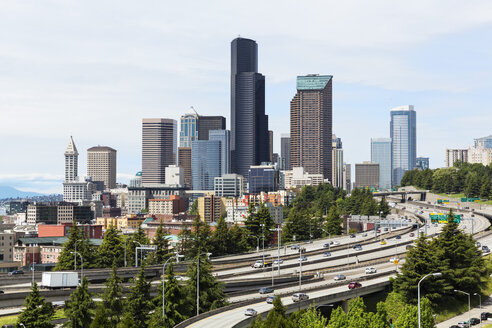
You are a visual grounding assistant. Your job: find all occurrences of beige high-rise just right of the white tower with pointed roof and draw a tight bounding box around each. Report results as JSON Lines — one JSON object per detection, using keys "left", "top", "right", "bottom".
{"left": 87, "top": 146, "right": 116, "bottom": 190}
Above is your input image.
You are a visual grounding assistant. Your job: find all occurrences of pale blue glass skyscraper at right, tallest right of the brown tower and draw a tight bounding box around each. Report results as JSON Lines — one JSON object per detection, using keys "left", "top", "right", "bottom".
{"left": 390, "top": 105, "right": 417, "bottom": 186}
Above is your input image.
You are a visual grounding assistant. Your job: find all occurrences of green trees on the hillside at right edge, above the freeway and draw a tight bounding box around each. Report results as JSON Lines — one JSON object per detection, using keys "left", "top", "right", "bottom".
{"left": 401, "top": 161, "right": 492, "bottom": 199}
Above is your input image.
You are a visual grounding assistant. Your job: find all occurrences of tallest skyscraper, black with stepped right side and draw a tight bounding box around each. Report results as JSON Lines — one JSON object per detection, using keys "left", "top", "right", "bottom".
{"left": 231, "top": 38, "right": 270, "bottom": 177}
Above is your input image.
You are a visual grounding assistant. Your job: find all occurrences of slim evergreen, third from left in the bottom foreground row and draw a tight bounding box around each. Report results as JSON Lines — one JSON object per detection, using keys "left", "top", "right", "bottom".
{"left": 102, "top": 261, "right": 123, "bottom": 327}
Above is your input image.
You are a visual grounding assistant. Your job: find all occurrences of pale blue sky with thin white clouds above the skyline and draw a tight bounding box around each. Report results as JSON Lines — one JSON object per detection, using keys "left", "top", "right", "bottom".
{"left": 0, "top": 0, "right": 492, "bottom": 193}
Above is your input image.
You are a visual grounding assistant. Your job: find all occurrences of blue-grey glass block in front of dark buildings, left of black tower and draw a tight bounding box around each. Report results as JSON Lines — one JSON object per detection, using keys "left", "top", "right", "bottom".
{"left": 191, "top": 140, "right": 221, "bottom": 190}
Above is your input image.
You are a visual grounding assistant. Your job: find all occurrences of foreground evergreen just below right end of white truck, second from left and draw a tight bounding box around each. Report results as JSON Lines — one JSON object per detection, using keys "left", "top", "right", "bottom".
{"left": 65, "top": 276, "right": 94, "bottom": 328}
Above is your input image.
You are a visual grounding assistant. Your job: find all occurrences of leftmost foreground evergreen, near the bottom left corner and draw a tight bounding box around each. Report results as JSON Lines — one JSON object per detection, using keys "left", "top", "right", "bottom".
{"left": 17, "top": 282, "right": 55, "bottom": 328}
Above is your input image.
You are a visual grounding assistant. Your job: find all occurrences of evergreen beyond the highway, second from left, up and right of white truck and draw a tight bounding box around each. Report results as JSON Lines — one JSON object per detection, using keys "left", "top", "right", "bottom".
{"left": 97, "top": 225, "right": 124, "bottom": 268}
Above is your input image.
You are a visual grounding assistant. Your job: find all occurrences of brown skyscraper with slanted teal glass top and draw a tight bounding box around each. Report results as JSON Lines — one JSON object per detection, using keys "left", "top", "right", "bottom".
{"left": 290, "top": 75, "right": 333, "bottom": 179}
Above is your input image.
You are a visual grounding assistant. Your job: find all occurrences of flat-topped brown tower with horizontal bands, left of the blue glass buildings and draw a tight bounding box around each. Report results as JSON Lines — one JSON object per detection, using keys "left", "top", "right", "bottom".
{"left": 142, "top": 118, "right": 177, "bottom": 185}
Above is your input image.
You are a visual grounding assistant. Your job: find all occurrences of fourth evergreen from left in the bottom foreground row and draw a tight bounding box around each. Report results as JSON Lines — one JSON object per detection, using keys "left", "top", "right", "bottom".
{"left": 123, "top": 266, "right": 152, "bottom": 327}
